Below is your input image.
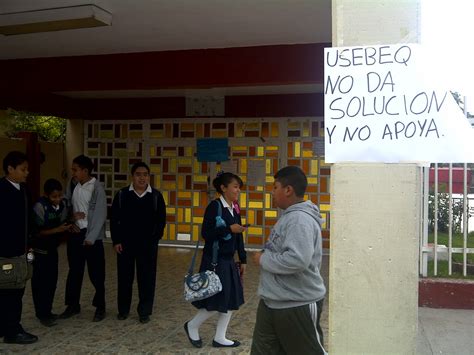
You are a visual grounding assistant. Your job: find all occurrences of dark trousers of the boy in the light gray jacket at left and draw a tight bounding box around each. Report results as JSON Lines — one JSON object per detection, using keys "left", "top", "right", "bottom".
{"left": 65, "top": 229, "right": 105, "bottom": 309}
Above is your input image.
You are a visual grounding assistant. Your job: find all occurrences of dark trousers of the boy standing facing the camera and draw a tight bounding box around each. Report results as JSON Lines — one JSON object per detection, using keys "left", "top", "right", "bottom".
{"left": 117, "top": 244, "right": 158, "bottom": 316}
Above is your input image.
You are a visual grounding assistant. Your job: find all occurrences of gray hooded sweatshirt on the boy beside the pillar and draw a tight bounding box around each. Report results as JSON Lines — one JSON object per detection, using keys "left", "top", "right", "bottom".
{"left": 258, "top": 201, "right": 326, "bottom": 308}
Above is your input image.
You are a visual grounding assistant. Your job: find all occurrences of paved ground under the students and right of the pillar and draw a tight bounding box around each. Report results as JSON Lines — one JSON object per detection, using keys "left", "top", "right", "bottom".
{"left": 0, "top": 244, "right": 474, "bottom": 355}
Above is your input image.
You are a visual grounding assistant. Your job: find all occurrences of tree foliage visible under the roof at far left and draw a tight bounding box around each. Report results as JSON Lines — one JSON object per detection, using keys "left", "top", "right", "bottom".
{"left": 2, "top": 109, "right": 66, "bottom": 142}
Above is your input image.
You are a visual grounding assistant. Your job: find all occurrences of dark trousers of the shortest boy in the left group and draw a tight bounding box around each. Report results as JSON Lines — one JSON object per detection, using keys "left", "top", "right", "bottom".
{"left": 31, "top": 248, "right": 58, "bottom": 318}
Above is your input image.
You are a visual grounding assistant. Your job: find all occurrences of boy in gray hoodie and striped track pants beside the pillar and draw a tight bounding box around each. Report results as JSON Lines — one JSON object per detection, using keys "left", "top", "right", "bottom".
{"left": 251, "top": 166, "right": 326, "bottom": 355}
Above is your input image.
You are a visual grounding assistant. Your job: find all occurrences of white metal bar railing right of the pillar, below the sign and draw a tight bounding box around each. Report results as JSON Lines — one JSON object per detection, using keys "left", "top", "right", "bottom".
{"left": 420, "top": 98, "right": 474, "bottom": 277}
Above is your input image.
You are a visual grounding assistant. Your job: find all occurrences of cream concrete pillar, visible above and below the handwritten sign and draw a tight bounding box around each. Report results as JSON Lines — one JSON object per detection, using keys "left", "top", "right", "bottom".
{"left": 328, "top": 0, "right": 421, "bottom": 354}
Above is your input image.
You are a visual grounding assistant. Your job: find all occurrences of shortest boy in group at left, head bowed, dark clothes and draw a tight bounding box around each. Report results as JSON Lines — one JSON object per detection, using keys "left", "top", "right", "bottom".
{"left": 31, "top": 179, "right": 71, "bottom": 327}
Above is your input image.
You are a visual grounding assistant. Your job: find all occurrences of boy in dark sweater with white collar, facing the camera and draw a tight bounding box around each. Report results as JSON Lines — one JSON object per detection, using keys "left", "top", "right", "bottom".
{"left": 110, "top": 162, "right": 166, "bottom": 323}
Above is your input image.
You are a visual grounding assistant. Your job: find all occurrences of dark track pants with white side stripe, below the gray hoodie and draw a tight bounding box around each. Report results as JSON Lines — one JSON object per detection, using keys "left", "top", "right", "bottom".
{"left": 251, "top": 300, "right": 326, "bottom": 355}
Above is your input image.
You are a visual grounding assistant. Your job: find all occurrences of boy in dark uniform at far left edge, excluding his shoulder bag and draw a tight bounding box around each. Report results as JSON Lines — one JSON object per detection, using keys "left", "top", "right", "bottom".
{"left": 0, "top": 151, "right": 38, "bottom": 344}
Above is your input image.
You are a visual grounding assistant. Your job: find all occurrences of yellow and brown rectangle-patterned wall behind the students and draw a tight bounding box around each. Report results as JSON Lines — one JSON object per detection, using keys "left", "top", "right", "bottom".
{"left": 85, "top": 118, "right": 330, "bottom": 246}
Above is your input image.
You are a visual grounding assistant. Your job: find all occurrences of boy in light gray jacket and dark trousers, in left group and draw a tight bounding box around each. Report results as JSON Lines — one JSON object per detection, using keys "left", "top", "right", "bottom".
{"left": 59, "top": 155, "right": 107, "bottom": 322}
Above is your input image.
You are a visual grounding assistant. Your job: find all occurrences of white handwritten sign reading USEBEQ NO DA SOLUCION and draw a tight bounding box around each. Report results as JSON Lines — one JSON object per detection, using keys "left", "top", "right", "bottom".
{"left": 324, "top": 44, "right": 474, "bottom": 163}
